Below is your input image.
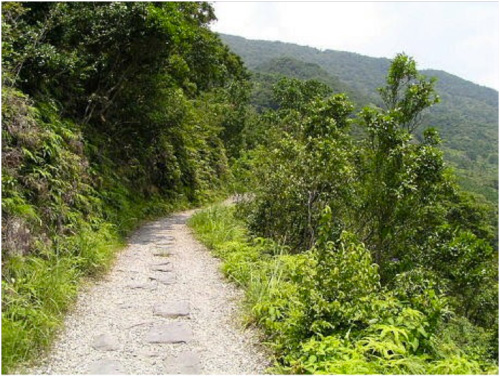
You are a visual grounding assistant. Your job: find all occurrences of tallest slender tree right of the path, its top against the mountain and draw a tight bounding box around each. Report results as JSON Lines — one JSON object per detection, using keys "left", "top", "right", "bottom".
{"left": 357, "top": 54, "right": 449, "bottom": 279}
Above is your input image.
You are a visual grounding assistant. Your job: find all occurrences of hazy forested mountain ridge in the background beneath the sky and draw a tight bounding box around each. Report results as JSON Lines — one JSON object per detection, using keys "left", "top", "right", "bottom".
{"left": 219, "top": 34, "right": 498, "bottom": 203}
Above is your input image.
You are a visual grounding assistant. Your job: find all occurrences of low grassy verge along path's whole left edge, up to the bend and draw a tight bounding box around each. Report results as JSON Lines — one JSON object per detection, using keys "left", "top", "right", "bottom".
{"left": 2, "top": 195, "right": 225, "bottom": 374}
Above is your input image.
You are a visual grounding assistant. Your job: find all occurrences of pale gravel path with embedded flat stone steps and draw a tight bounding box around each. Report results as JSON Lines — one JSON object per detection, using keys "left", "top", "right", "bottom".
{"left": 20, "top": 211, "right": 269, "bottom": 374}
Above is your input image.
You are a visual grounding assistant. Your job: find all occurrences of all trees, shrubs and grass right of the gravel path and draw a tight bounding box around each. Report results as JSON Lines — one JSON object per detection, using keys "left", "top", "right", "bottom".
{"left": 192, "top": 55, "right": 498, "bottom": 374}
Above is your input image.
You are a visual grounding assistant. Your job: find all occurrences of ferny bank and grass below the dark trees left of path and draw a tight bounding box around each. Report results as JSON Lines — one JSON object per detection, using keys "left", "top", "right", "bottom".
{"left": 2, "top": 86, "right": 224, "bottom": 373}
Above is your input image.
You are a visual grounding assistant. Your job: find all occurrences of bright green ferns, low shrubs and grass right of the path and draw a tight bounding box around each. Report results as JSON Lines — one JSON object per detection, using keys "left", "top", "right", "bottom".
{"left": 189, "top": 206, "right": 498, "bottom": 374}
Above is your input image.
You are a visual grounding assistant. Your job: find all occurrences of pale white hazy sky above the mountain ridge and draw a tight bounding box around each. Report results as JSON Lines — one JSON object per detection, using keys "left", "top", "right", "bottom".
{"left": 212, "top": 2, "right": 499, "bottom": 90}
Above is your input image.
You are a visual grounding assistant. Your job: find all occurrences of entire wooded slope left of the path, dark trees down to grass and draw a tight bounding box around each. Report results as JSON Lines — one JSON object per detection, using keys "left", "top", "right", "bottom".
{"left": 2, "top": 2, "right": 246, "bottom": 372}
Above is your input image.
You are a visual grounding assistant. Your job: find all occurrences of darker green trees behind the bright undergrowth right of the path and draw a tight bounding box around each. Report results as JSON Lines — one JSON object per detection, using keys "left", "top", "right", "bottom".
{"left": 240, "top": 55, "right": 497, "bottom": 326}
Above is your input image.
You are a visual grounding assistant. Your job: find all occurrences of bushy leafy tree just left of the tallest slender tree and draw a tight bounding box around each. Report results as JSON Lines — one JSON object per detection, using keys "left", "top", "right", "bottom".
{"left": 241, "top": 85, "right": 355, "bottom": 249}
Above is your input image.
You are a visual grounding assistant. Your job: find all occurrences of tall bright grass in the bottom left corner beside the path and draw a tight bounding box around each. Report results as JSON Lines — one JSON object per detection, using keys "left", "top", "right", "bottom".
{"left": 2, "top": 226, "right": 118, "bottom": 373}
